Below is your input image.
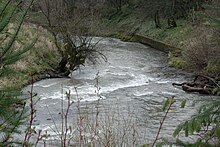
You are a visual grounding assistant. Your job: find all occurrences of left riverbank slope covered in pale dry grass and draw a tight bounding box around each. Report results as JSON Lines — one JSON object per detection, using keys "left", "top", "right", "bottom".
{"left": 0, "top": 23, "right": 59, "bottom": 89}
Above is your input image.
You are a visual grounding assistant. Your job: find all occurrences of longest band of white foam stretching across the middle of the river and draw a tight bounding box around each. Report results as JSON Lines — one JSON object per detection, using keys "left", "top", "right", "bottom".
{"left": 35, "top": 73, "right": 157, "bottom": 101}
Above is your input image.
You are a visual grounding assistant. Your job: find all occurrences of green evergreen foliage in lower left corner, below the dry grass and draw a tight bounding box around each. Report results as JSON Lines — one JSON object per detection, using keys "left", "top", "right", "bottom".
{"left": 0, "top": 89, "right": 25, "bottom": 146}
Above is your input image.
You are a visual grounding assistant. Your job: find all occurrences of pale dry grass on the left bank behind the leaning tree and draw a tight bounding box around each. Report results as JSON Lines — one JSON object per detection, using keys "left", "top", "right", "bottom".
{"left": 0, "top": 23, "right": 59, "bottom": 88}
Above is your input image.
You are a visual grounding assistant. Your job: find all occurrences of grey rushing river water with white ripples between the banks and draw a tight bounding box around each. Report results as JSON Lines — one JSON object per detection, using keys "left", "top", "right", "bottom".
{"left": 24, "top": 38, "right": 215, "bottom": 146}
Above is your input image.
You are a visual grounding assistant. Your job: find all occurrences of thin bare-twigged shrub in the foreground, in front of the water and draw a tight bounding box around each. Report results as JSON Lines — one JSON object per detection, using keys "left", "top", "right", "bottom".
{"left": 23, "top": 75, "right": 138, "bottom": 147}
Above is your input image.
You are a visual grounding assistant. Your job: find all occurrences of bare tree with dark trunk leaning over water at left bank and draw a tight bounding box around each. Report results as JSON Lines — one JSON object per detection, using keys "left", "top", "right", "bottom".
{"left": 36, "top": 0, "right": 106, "bottom": 76}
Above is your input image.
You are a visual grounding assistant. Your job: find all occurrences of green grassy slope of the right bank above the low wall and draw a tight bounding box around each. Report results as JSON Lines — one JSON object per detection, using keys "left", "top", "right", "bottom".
{"left": 98, "top": 2, "right": 220, "bottom": 76}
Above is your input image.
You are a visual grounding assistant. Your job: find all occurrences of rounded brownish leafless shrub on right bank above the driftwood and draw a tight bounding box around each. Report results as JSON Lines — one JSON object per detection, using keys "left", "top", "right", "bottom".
{"left": 184, "top": 32, "right": 220, "bottom": 75}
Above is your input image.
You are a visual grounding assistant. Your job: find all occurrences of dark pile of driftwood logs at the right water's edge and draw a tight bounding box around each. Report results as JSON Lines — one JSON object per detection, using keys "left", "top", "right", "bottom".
{"left": 172, "top": 75, "right": 220, "bottom": 94}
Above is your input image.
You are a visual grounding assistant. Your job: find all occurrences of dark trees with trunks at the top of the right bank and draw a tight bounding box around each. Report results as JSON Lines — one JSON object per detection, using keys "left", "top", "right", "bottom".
{"left": 137, "top": 0, "right": 204, "bottom": 28}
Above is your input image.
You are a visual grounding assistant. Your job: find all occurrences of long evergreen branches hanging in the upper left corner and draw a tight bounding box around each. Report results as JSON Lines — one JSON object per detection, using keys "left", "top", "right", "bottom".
{"left": 0, "top": 1, "right": 36, "bottom": 75}
